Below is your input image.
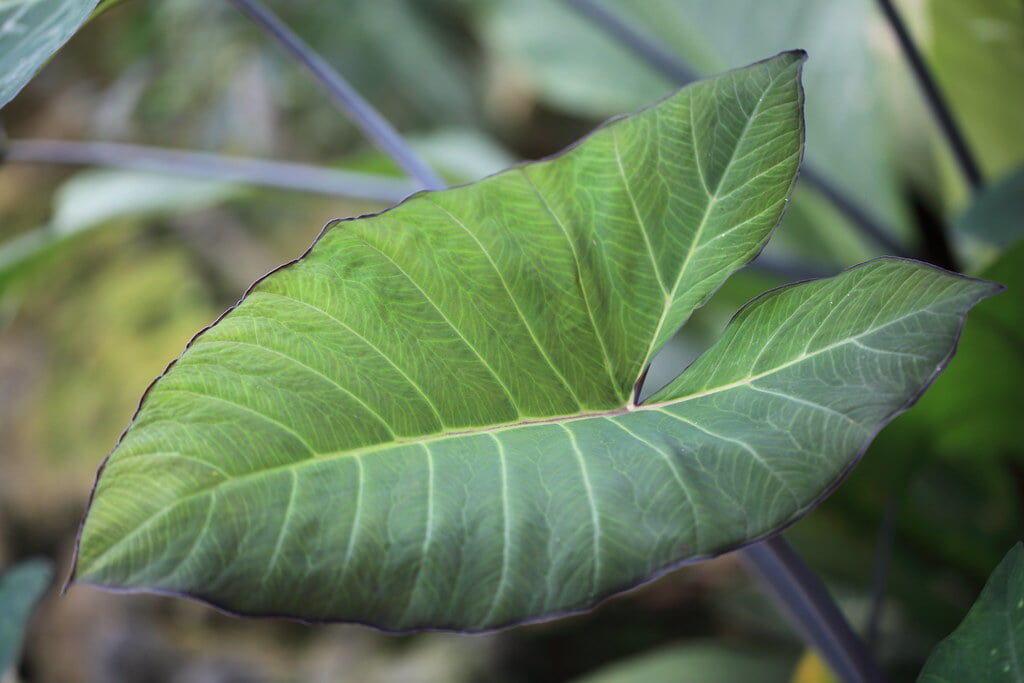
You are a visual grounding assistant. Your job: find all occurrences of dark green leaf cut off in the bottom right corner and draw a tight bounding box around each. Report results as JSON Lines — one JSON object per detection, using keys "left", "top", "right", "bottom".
{"left": 918, "top": 543, "right": 1024, "bottom": 683}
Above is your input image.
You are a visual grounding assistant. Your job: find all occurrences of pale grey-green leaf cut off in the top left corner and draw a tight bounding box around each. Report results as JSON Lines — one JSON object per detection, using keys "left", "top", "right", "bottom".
{"left": 0, "top": 0, "right": 97, "bottom": 106}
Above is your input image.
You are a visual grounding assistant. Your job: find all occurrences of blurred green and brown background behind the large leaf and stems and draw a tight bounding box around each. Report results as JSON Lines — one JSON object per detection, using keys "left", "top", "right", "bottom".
{"left": 0, "top": 0, "right": 1024, "bottom": 683}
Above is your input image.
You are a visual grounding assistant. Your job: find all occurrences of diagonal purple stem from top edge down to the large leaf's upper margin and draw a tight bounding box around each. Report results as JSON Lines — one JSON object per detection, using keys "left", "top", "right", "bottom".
{"left": 231, "top": 0, "right": 447, "bottom": 189}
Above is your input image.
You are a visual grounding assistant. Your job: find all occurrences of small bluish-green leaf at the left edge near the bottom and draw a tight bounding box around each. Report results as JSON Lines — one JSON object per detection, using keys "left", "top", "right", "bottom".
{"left": 0, "top": 560, "right": 53, "bottom": 678}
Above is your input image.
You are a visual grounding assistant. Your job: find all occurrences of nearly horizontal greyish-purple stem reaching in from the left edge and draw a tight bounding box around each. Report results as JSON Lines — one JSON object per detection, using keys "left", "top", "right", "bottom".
{"left": 3, "top": 140, "right": 416, "bottom": 202}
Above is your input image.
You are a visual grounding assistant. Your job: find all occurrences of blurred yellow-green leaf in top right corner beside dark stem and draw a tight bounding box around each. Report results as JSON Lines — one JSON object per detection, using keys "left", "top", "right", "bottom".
{"left": 926, "top": 0, "right": 1024, "bottom": 177}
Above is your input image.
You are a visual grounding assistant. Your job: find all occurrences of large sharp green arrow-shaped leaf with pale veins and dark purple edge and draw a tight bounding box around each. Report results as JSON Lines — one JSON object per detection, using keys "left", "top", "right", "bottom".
{"left": 74, "top": 53, "right": 992, "bottom": 630}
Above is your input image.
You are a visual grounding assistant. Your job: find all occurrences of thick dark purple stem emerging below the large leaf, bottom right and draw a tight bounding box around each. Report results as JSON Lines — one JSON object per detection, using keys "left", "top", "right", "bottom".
{"left": 740, "top": 535, "right": 885, "bottom": 683}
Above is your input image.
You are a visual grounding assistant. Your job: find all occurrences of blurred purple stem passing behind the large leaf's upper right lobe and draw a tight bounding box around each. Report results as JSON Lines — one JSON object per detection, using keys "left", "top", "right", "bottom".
{"left": 562, "top": 0, "right": 909, "bottom": 256}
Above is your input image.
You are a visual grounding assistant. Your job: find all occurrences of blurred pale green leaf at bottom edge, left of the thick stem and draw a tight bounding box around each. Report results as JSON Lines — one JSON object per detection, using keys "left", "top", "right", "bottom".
{"left": 574, "top": 643, "right": 793, "bottom": 683}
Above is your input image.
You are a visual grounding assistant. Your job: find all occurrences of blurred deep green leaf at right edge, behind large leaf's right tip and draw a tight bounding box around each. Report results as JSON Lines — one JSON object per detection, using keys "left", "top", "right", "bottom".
{"left": 901, "top": 242, "right": 1024, "bottom": 461}
